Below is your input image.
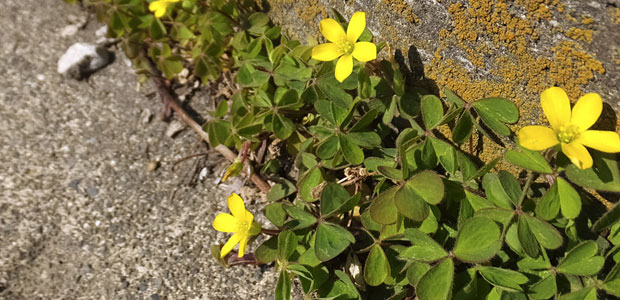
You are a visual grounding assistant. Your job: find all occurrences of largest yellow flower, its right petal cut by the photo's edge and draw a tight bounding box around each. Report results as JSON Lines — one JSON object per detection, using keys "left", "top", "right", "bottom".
{"left": 517, "top": 87, "right": 620, "bottom": 169}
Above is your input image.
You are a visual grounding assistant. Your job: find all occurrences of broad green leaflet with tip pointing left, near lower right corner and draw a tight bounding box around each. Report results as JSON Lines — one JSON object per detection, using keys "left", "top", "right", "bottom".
{"left": 557, "top": 241, "right": 605, "bottom": 276}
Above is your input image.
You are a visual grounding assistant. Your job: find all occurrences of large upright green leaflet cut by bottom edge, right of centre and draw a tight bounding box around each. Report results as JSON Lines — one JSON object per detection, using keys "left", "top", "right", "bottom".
{"left": 416, "top": 258, "right": 454, "bottom": 300}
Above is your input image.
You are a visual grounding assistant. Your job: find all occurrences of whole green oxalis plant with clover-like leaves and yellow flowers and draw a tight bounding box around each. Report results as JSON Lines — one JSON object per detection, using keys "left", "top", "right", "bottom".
{"left": 66, "top": 0, "right": 620, "bottom": 300}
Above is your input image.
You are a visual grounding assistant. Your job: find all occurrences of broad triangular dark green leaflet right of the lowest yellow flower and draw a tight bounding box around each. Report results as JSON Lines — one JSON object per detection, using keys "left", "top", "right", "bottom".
{"left": 314, "top": 222, "right": 355, "bottom": 261}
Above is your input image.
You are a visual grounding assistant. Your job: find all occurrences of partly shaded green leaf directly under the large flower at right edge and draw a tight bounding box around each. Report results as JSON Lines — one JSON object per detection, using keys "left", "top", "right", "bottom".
{"left": 566, "top": 149, "right": 620, "bottom": 192}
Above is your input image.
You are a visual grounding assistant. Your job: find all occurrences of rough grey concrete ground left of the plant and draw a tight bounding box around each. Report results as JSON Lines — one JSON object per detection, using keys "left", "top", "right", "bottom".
{"left": 0, "top": 0, "right": 277, "bottom": 300}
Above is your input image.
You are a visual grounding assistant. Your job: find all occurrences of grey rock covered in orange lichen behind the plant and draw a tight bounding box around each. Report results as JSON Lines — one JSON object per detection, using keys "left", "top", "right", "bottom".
{"left": 264, "top": 0, "right": 620, "bottom": 164}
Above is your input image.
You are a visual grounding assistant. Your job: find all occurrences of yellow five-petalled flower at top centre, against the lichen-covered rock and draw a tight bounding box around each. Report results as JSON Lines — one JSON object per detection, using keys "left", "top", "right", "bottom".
{"left": 312, "top": 11, "right": 377, "bottom": 82}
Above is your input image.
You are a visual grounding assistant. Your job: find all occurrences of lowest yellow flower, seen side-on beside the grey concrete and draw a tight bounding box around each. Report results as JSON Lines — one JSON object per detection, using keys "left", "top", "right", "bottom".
{"left": 213, "top": 193, "right": 261, "bottom": 257}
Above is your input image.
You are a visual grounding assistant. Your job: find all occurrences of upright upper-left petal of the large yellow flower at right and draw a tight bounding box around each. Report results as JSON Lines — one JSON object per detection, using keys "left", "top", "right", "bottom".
{"left": 540, "top": 87, "right": 570, "bottom": 132}
